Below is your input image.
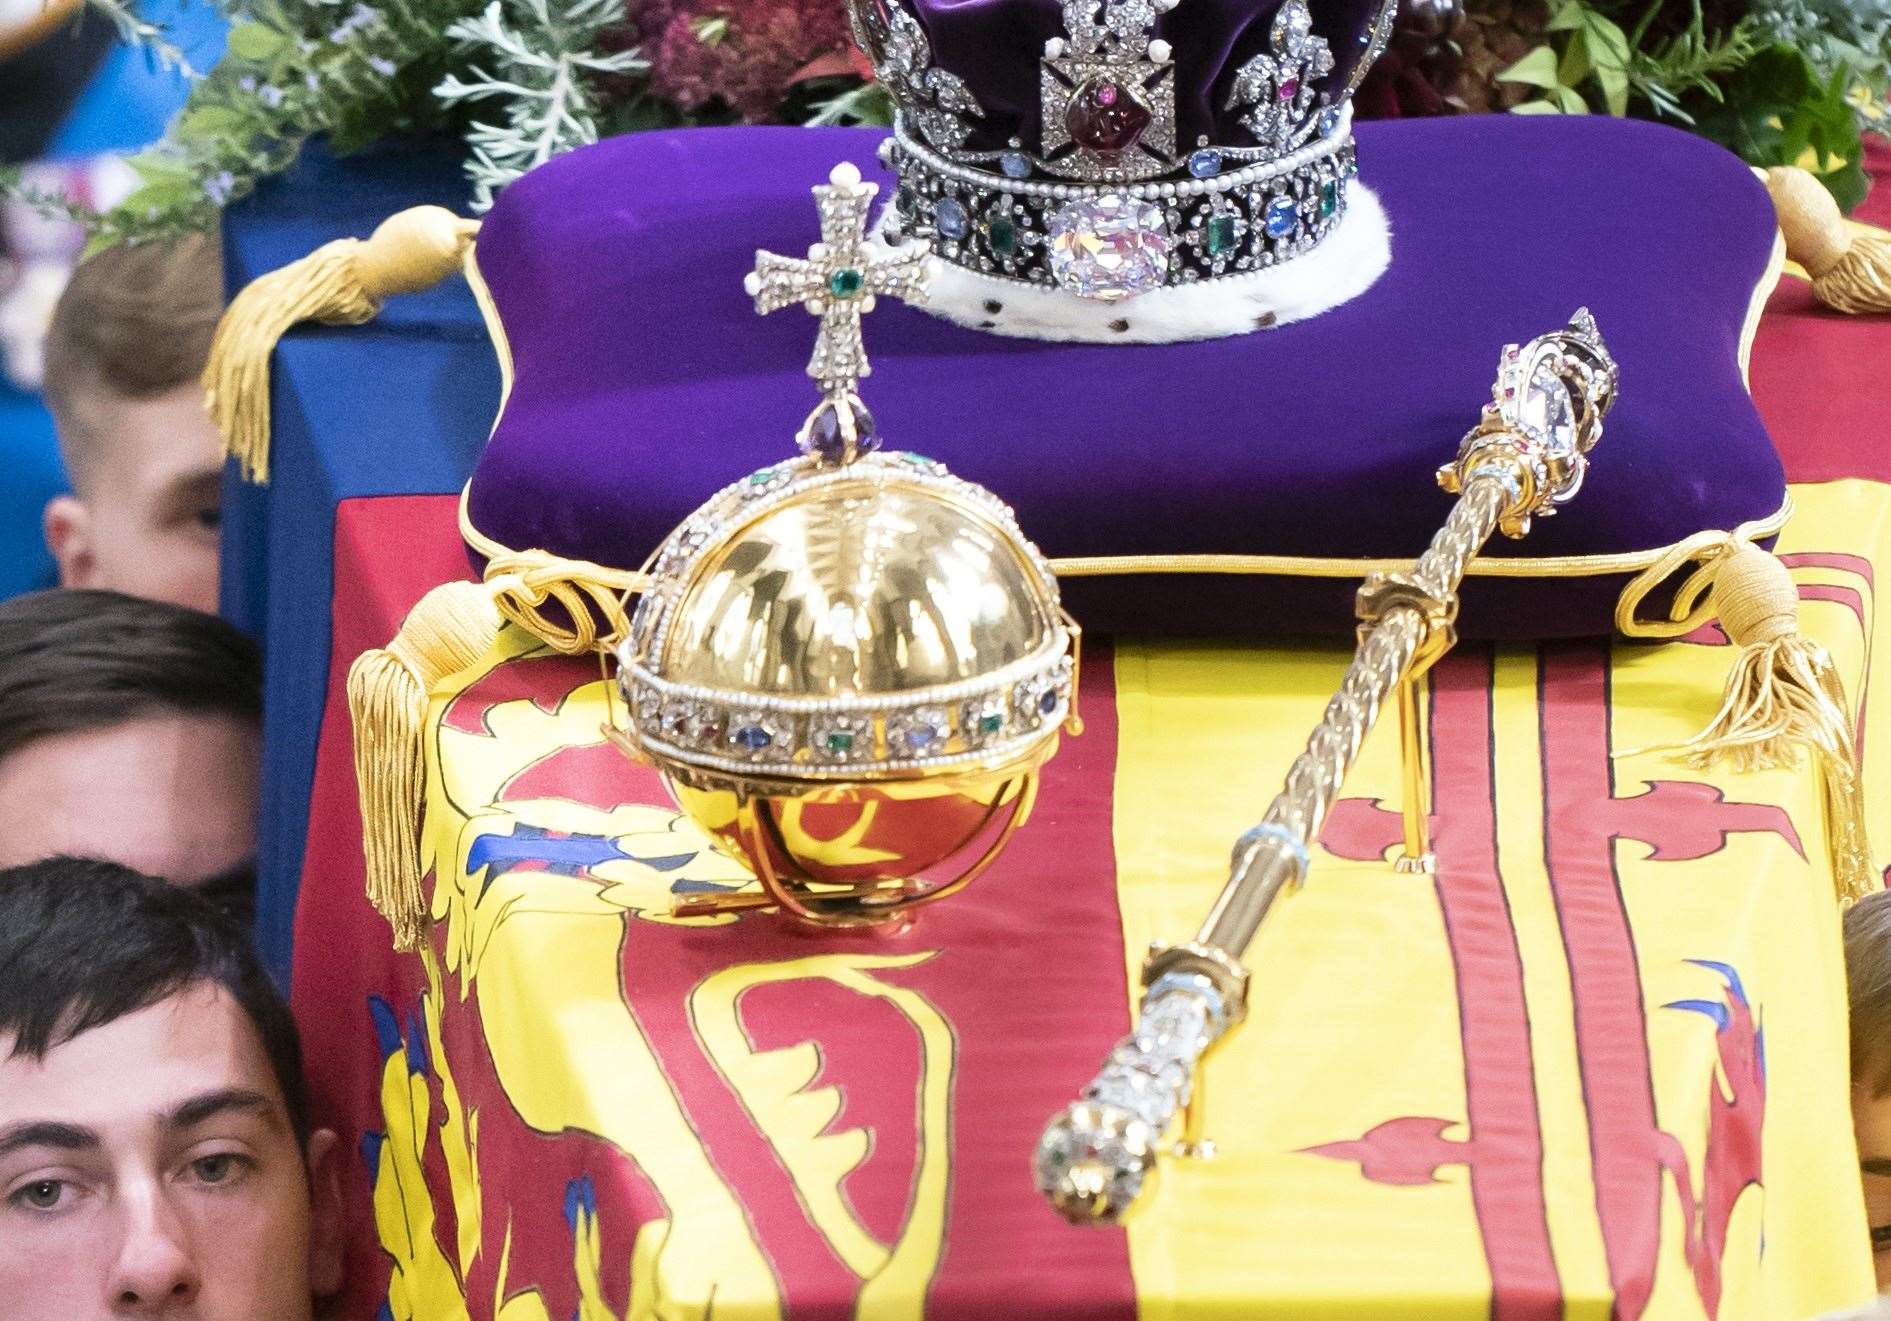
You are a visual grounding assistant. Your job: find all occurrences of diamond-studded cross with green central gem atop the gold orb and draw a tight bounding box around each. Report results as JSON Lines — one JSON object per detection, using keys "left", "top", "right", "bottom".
{"left": 743, "top": 161, "right": 927, "bottom": 395}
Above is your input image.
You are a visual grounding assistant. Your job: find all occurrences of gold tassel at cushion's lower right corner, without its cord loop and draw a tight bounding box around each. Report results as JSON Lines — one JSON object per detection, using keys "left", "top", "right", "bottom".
{"left": 1677, "top": 544, "right": 1878, "bottom": 907}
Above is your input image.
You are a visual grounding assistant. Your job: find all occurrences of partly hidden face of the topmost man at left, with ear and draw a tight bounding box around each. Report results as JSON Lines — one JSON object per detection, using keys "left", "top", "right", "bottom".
{"left": 45, "top": 382, "right": 223, "bottom": 612}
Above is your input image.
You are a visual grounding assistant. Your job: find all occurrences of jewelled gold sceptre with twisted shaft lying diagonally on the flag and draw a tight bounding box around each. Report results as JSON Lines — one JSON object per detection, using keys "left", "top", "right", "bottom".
{"left": 1034, "top": 310, "right": 1619, "bottom": 1225}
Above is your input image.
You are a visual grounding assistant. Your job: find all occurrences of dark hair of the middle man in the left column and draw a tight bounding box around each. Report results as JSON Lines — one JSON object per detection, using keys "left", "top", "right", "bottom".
{"left": 0, "top": 588, "right": 263, "bottom": 758}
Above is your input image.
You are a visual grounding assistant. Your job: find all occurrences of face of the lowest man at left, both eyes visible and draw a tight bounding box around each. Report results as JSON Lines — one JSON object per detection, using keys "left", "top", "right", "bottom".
{"left": 0, "top": 983, "right": 340, "bottom": 1321}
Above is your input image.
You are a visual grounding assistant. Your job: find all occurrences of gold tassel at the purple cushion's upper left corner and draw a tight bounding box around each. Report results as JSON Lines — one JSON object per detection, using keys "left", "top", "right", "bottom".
{"left": 204, "top": 206, "right": 478, "bottom": 482}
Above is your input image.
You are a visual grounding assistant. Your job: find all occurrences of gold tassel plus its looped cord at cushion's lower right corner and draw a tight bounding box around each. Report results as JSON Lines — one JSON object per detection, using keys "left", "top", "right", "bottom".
{"left": 1615, "top": 523, "right": 1878, "bottom": 907}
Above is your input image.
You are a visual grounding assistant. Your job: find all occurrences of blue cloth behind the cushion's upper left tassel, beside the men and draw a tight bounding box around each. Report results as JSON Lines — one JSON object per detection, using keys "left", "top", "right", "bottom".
{"left": 223, "top": 146, "right": 499, "bottom": 977}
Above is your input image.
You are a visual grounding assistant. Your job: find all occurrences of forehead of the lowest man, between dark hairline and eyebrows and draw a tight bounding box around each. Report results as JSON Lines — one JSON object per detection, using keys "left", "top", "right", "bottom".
{"left": 0, "top": 983, "right": 284, "bottom": 1130}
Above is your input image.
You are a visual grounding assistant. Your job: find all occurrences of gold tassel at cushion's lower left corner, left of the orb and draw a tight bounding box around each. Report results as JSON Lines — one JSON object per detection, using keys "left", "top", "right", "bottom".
{"left": 348, "top": 582, "right": 499, "bottom": 949}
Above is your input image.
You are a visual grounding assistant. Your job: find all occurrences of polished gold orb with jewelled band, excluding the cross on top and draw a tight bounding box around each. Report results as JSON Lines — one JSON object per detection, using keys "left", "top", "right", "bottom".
{"left": 618, "top": 454, "right": 1080, "bottom": 926}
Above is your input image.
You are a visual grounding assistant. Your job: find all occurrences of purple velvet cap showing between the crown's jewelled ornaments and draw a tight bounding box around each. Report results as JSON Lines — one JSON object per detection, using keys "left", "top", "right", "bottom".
{"left": 907, "top": 0, "right": 1379, "bottom": 153}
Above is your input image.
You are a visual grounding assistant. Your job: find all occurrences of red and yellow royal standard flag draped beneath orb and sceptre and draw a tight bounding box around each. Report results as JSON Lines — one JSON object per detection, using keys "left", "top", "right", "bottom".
{"left": 297, "top": 470, "right": 1891, "bottom": 1321}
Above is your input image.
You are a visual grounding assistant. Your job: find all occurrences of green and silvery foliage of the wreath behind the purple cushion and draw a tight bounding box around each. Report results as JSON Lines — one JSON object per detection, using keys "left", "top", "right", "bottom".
{"left": 11, "top": 0, "right": 1891, "bottom": 235}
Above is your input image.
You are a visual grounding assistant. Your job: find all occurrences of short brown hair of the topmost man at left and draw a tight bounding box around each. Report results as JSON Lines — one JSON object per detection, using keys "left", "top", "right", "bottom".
{"left": 43, "top": 232, "right": 223, "bottom": 488}
